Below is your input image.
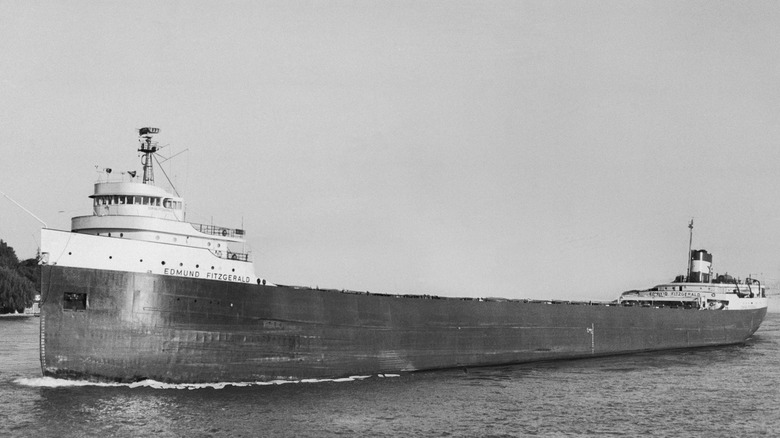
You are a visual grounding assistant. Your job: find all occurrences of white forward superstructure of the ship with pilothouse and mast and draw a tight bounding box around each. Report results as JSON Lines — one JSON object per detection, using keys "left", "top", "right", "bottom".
{"left": 41, "top": 128, "right": 265, "bottom": 284}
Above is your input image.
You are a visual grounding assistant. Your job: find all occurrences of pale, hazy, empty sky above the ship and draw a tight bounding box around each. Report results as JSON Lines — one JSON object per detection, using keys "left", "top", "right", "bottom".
{"left": 0, "top": 0, "right": 780, "bottom": 306}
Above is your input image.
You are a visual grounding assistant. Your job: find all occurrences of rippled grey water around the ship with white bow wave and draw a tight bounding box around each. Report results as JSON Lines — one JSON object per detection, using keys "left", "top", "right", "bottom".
{"left": 0, "top": 314, "right": 780, "bottom": 437}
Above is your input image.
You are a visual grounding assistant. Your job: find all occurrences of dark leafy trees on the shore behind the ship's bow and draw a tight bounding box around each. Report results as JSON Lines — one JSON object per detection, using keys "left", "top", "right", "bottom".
{"left": 0, "top": 240, "right": 41, "bottom": 314}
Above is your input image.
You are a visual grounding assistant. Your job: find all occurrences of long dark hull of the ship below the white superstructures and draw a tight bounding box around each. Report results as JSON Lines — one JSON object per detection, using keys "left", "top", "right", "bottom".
{"left": 41, "top": 265, "right": 766, "bottom": 383}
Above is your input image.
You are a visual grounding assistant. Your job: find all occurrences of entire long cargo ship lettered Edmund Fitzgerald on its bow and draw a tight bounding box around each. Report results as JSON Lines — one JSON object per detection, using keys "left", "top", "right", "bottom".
{"left": 40, "top": 128, "right": 767, "bottom": 383}
